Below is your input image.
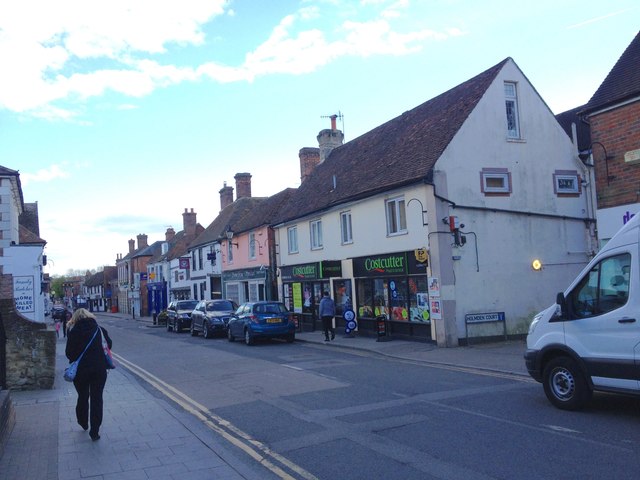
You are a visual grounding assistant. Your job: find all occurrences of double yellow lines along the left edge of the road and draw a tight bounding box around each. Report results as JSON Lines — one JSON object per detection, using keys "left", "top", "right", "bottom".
{"left": 112, "top": 352, "right": 319, "bottom": 480}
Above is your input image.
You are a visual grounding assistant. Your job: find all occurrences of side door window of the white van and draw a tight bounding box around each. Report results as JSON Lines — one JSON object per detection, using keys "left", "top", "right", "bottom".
{"left": 567, "top": 253, "right": 631, "bottom": 318}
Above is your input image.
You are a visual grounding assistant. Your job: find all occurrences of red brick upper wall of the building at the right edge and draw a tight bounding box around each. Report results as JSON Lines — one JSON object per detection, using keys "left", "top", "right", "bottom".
{"left": 589, "top": 102, "right": 640, "bottom": 209}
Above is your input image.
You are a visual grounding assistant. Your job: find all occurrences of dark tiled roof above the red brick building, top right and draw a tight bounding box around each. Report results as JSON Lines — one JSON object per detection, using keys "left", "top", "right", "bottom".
{"left": 584, "top": 32, "right": 640, "bottom": 113}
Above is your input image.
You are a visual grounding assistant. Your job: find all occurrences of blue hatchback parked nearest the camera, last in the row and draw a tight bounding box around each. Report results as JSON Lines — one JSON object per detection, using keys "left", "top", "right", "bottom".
{"left": 227, "top": 301, "right": 296, "bottom": 345}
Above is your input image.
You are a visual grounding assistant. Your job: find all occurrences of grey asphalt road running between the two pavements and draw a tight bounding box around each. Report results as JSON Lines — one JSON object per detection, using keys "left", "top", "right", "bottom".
{"left": 100, "top": 316, "right": 640, "bottom": 480}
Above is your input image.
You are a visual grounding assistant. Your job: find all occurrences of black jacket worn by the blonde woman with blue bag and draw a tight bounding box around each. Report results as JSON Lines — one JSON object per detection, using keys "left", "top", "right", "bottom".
{"left": 65, "top": 318, "right": 112, "bottom": 378}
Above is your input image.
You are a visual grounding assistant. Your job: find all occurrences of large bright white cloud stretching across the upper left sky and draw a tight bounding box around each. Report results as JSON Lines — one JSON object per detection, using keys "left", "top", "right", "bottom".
{"left": 0, "top": 0, "right": 459, "bottom": 120}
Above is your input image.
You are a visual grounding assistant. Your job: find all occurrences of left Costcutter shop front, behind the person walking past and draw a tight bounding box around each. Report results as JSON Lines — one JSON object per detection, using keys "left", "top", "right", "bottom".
{"left": 280, "top": 260, "right": 344, "bottom": 331}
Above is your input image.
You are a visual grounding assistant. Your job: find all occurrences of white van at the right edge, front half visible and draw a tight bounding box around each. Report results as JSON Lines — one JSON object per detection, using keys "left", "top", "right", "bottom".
{"left": 524, "top": 214, "right": 640, "bottom": 410}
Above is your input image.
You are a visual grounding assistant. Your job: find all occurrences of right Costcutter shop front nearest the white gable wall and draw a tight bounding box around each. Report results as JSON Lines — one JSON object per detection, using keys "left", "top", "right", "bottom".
{"left": 352, "top": 249, "right": 432, "bottom": 340}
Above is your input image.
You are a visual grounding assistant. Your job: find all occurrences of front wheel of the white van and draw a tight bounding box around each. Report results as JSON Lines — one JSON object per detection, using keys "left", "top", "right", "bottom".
{"left": 542, "top": 357, "right": 591, "bottom": 410}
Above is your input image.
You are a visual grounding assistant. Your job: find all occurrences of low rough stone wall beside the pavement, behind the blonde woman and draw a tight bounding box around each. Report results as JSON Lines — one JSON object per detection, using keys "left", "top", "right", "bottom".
{"left": 0, "top": 275, "right": 56, "bottom": 390}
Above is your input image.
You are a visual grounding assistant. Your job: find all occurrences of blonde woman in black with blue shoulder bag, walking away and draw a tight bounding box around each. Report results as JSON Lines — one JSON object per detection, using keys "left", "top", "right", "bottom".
{"left": 65, "top": 308, "right": 112, "bottom": 441}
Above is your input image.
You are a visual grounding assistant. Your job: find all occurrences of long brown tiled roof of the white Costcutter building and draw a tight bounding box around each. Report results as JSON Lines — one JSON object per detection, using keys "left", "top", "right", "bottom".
{"left": 274, "top": 58, "right": 510, "bottom": 224}
